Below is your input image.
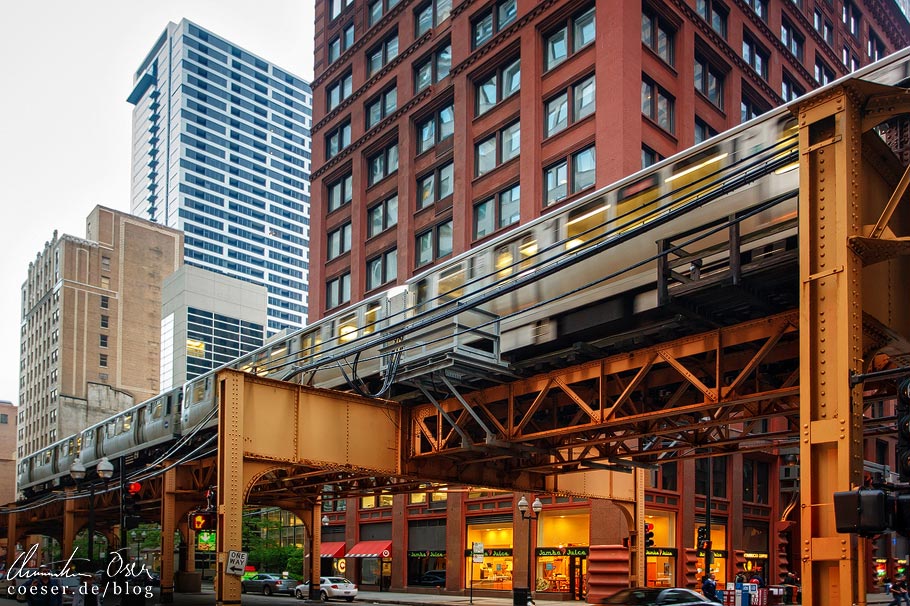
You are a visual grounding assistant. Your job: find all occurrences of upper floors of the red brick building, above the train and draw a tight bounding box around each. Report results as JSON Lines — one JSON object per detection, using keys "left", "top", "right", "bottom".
{"left": 310, "top": 0, "right": 910, "bottom": 319}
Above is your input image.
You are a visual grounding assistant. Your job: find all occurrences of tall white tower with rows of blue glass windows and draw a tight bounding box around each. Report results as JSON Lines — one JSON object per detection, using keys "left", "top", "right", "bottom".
{"left": 128, "top": 19, "right": 312, "bottom": 334}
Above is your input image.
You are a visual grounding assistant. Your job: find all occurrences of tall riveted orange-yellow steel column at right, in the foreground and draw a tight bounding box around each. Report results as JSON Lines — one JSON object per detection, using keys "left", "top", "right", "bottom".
{"left": 798, "top": 85, "right": 866, "bottom": 606}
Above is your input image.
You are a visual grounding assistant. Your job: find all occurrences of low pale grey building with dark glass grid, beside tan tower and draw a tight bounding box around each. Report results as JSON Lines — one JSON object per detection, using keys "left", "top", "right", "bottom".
{"left": 161, "top": 265, "right": 268, "bottom": 390}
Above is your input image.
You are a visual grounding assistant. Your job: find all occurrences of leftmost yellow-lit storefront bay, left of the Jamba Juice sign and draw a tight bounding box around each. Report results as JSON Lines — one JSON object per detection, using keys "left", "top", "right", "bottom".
{"left": 465, "top": 515, "right": 512, "bottom": 591}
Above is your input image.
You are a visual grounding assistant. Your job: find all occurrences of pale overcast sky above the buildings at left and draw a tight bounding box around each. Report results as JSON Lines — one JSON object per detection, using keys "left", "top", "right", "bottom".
{"left": 0, "top": 0, "right": 316, "bottom": 404}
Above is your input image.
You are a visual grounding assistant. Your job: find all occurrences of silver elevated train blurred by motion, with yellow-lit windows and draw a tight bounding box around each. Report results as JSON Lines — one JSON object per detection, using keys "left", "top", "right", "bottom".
{"left": 18, "top": 49, "right": 910, "bottom": 497}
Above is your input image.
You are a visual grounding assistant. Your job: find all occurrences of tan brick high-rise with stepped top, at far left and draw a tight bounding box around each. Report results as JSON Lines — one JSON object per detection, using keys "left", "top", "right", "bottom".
{"left": 17, "top": 206, "right": 183, "bottom": 457}
